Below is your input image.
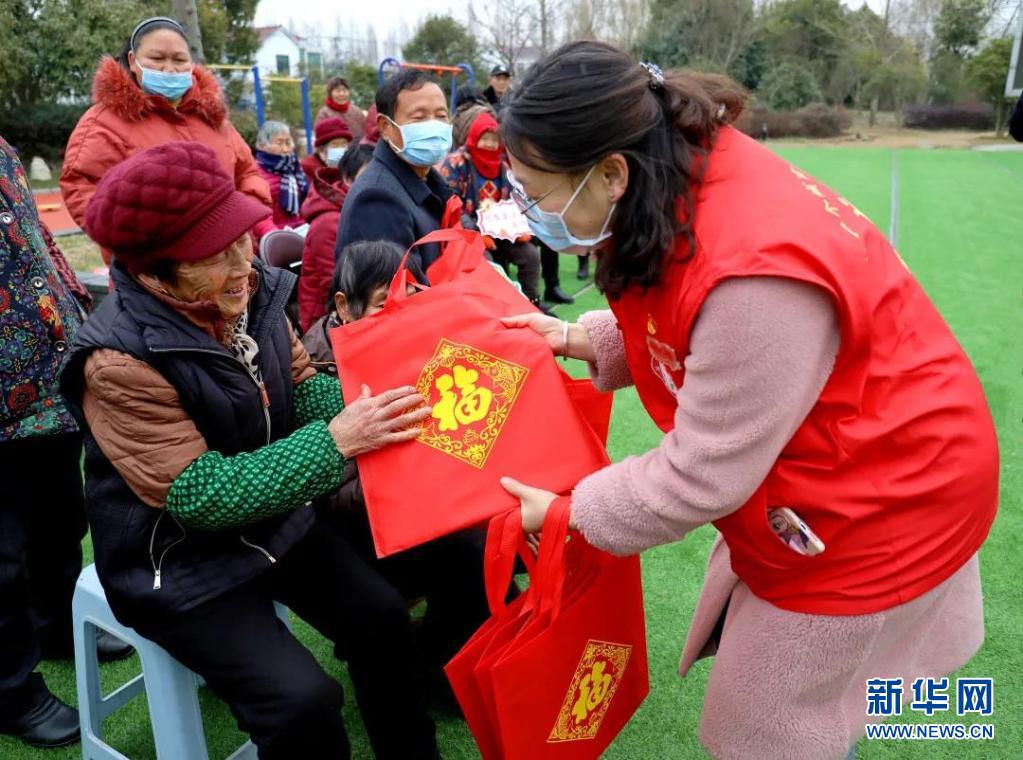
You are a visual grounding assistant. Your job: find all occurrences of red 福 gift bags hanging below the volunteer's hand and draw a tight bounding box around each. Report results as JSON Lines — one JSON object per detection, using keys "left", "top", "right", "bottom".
{"left": 448, "top": 499, "right": 650, "bottom": 760}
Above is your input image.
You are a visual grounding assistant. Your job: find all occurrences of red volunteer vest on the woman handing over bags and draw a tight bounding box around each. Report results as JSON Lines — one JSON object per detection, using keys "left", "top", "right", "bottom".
{"left": 612, "top": 127, "right": 998, "bottom": 615}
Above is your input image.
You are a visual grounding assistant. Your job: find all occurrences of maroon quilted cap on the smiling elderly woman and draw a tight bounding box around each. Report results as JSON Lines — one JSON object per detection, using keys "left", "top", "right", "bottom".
{"left": 85, "top": 142, "right": 270, "bottom": 267}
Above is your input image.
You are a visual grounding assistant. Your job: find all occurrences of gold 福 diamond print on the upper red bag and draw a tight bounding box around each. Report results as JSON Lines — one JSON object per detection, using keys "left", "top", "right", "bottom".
{"left": 416, "top": 338, "right": 529, "bottom": 470}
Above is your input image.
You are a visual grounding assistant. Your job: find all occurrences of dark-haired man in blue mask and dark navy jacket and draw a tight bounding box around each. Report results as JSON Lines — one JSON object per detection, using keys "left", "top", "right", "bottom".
{"left": 335, "top": 69, "right": 453, "bottom": 270}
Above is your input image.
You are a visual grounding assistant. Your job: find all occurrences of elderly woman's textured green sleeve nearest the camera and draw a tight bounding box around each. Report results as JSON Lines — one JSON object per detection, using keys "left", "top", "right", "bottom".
{"left": 167, "top": 419, "right": 345, "bottom": 531}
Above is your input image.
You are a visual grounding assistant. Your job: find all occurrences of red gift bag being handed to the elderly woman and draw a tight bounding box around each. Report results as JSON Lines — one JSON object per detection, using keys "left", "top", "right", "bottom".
{"left": 331, "top": 230, "right": 608, "bottom": 556}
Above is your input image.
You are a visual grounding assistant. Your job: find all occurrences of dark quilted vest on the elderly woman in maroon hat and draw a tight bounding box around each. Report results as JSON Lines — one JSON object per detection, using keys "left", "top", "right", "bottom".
{"left": 60, "top": 262, "right": 315, "bottom": 625}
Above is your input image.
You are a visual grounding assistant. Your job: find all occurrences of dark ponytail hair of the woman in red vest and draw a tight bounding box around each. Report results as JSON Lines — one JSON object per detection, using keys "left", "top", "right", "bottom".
{"left": 501, "top": 41, "right": 747, "bottom": 299}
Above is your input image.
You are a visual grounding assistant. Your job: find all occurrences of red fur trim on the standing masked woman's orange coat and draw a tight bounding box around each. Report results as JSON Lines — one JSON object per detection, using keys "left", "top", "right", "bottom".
{"left": 92, "top": 55, "right": 227, "bottom": 128}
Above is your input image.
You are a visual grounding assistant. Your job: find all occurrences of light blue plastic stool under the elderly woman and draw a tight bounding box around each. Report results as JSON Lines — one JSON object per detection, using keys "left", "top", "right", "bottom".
{"left": 72, "top": 565, "right": 291, "bottom": 760}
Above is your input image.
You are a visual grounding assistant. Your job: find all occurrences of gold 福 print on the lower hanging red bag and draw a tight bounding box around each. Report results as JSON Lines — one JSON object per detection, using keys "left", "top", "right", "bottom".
{"left": 547, "top": 639, "right": 632, "bottom": 744}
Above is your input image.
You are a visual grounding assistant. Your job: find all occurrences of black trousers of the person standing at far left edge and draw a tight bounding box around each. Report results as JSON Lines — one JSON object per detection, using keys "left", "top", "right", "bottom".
{"left": 0, "top": 435, "right": 86, "bottom": 718}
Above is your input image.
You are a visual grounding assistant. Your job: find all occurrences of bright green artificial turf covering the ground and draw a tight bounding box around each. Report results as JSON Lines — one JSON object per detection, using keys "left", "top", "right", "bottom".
{"left": 6, "top": 146, "right": 1023, "bottom": 760}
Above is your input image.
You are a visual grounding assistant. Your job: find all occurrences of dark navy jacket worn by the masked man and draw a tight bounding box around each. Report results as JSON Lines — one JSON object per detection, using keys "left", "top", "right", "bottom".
{"left": 335, "top": 140, "right": 452, "bottom": 270}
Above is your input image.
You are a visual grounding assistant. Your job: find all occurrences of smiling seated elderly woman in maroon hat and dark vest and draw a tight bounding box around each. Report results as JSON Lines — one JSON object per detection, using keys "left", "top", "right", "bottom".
{"left": 61, "top": 142, "right": 436, "bottom": 758}
